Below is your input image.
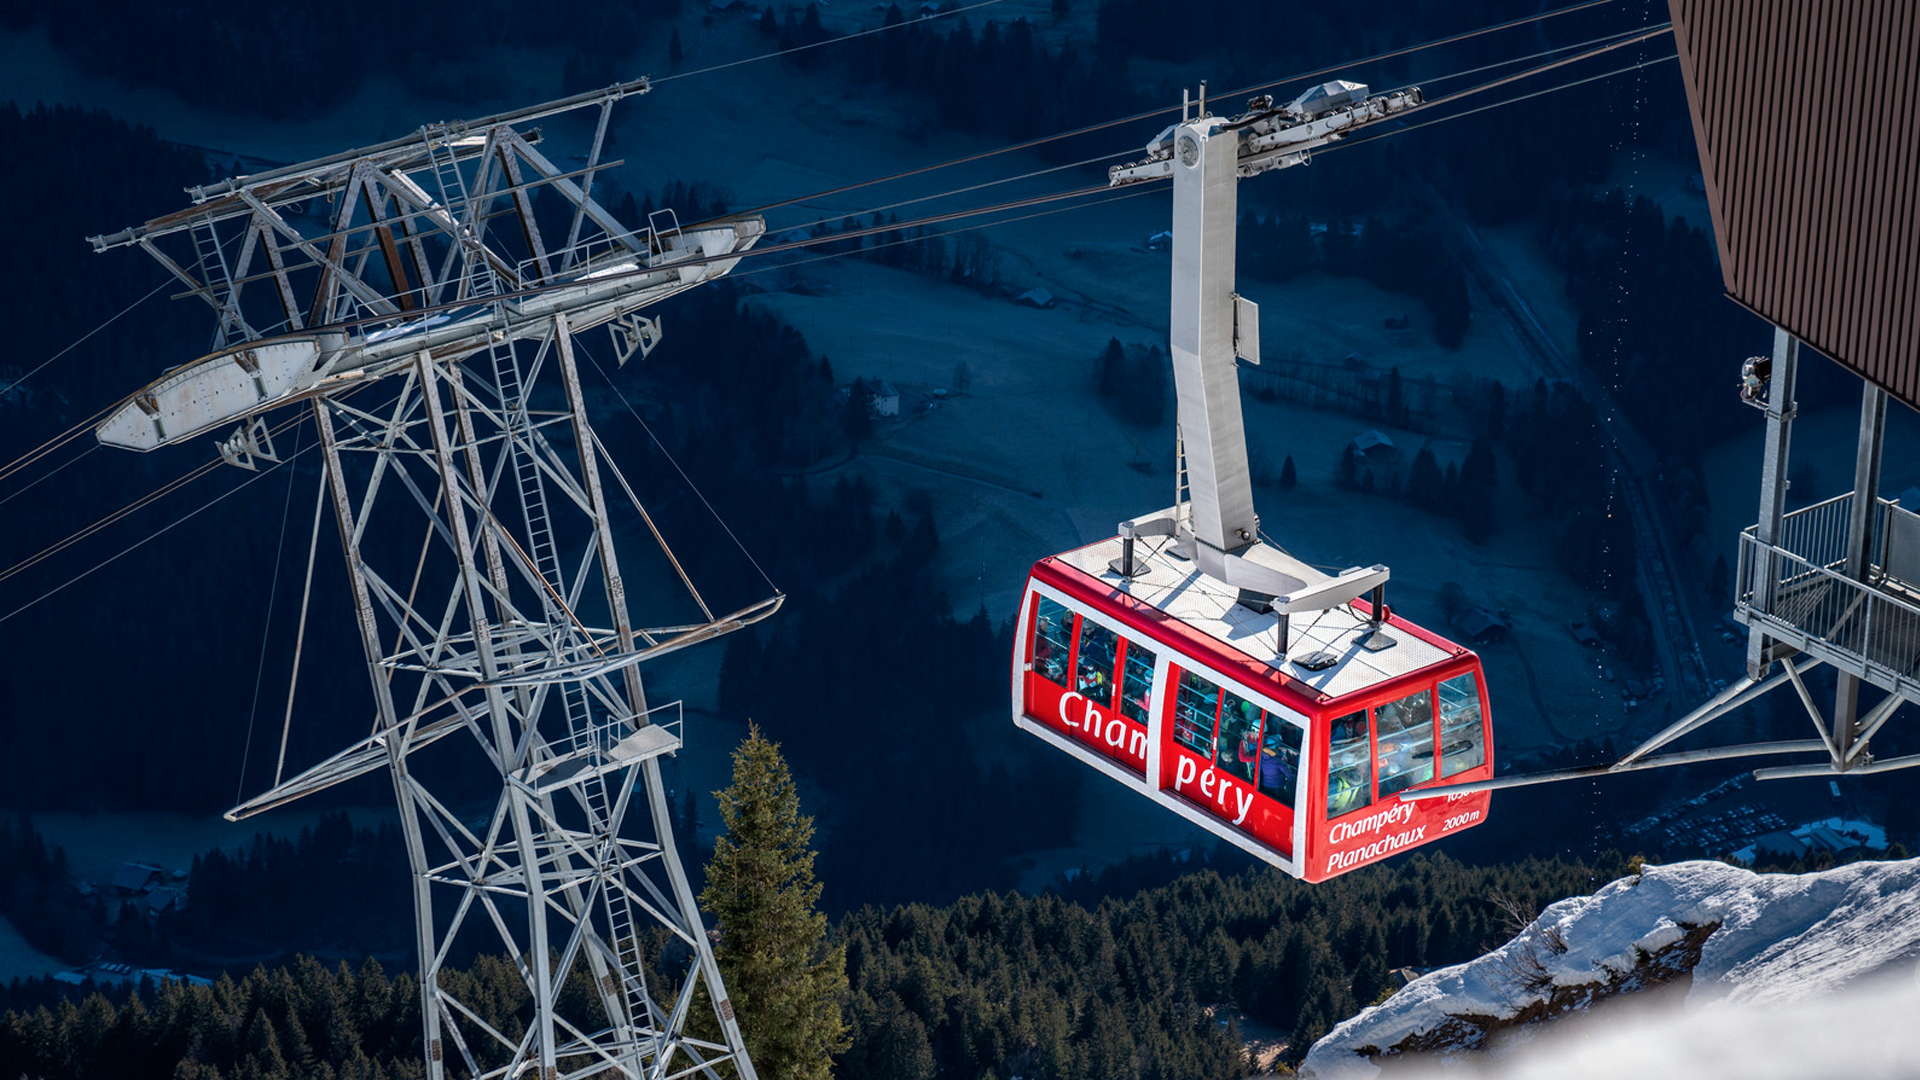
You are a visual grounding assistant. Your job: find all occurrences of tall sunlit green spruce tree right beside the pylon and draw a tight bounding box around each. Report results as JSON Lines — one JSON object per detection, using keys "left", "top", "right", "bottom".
{"left": 701, "top": 726, "right": 849, "bottom": 1080}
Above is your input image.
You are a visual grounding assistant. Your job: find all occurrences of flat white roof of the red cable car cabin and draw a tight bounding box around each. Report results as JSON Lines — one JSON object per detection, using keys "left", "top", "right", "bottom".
{"left": 1060, "top": 536, "right": 1452, "bottom": 698}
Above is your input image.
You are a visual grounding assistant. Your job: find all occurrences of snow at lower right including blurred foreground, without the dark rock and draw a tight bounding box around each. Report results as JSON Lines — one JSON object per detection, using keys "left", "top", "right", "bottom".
{"left": 1302, "top": 861, "right": 1920, "bottom": 1080}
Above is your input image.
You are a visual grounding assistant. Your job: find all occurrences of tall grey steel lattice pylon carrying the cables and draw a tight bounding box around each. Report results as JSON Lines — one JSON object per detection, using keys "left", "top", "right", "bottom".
{"left": 94, "top": 81, "right": 781, "bottom": 1080}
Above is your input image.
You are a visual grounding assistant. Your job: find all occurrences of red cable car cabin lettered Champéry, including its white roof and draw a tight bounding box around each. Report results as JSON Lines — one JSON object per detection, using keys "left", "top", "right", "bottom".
{"left": 1014, "top": 538, "right": 1492, "bottom": 882}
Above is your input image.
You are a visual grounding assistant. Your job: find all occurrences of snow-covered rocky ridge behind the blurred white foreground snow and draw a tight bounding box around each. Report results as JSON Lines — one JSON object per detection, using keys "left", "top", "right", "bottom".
{"left": 1302, "top": 859, "right": 1920, "bottom": 1080}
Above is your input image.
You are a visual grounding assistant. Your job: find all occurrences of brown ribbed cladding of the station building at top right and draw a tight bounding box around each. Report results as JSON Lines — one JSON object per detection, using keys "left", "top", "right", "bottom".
{"left": 1668, "top": 0, "right": 1920, "bottom": 409}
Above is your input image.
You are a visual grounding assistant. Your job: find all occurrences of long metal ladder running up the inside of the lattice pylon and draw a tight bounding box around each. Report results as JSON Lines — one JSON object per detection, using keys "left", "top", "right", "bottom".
{"left": 428, "top": 123, "right": 660, "bottom": 1061}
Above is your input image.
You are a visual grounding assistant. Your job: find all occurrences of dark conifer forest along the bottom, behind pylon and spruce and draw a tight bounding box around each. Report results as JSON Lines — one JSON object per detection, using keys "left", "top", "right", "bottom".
{"left": 0, "top": 855, "right": 1624, "bottom": 1080}
